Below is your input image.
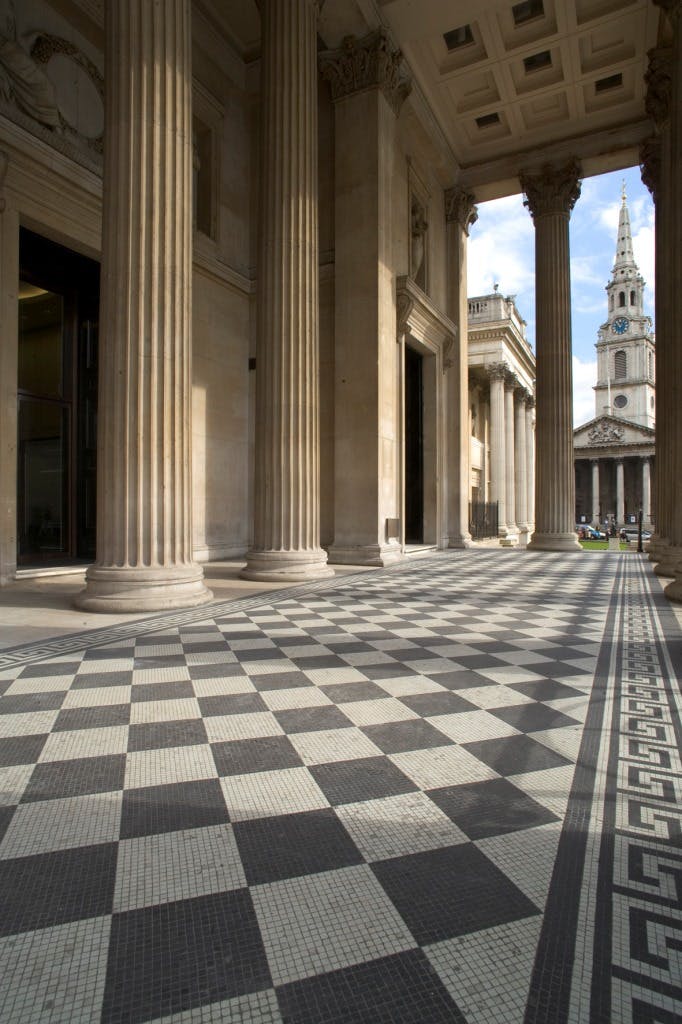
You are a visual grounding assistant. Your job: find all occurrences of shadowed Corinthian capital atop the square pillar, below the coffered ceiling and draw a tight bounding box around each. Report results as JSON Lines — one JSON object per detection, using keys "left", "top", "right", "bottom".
{"left": 319, "top": 29, "right": 412, "bottom": 117}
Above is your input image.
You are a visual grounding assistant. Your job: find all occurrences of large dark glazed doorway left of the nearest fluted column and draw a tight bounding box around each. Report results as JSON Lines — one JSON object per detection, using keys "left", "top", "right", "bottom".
{"left": 16, "top": 228, "right": 99, "bottom": 566}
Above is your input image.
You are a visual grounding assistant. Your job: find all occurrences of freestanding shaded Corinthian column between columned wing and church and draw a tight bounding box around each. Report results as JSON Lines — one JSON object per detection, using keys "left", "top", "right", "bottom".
{"left": 520, "top": 163, "right": 582, "bottom": 551}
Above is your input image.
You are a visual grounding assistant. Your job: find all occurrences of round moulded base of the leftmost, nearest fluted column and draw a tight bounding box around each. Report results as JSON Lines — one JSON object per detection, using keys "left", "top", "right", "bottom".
{"left": 74, "top": 563, "right": 213, "bottom": 612}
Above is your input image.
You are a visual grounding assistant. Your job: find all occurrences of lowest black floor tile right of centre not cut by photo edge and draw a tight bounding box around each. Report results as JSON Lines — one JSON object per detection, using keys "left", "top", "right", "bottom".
{"left": 372, "top": 843, "right": 538, "bottom": 945}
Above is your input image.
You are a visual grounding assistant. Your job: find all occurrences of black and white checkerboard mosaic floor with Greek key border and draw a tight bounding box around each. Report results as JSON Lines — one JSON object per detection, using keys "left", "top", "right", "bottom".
{"left": 0, "top": 550, "right": 682, "bottom": 1024}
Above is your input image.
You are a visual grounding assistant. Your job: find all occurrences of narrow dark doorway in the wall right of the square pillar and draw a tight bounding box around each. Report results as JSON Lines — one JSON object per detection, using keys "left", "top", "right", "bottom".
{"left": 404, "top": 346, "right": 424, "bottom": 544}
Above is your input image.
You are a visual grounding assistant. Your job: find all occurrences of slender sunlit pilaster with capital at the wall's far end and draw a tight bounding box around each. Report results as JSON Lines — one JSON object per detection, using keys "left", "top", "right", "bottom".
{"left": 444, "top": 186, "right": 478, "bottom": 548}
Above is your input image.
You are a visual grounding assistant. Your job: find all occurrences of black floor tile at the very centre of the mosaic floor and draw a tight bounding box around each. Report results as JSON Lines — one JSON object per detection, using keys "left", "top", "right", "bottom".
{"left": 308, "top": 758, "right": 417, "bottom": 806}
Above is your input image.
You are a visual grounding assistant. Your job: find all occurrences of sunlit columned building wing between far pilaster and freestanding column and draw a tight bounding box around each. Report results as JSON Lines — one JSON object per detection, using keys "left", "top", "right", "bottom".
{"left": 468, "top": 285, "right": 536, "bottom": 545}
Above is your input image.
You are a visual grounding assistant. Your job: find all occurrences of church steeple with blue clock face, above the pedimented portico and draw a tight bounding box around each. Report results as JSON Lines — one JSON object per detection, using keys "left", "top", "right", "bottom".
{"left": 594, "top": 184, "right": 655, "bottom": 427}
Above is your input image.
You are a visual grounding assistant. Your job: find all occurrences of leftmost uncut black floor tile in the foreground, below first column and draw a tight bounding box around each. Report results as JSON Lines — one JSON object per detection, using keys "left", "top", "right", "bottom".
{"left": 22, "top": 754, "right": 126, "bottom": 804}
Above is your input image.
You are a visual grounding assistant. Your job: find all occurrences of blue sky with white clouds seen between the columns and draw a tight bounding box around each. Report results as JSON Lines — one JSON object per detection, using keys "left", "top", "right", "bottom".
{"left": 467, "top": 167, "right": 653, "bottom": 426}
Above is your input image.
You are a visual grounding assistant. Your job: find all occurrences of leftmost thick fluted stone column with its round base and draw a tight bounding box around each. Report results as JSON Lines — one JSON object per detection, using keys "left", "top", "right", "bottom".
{"left": 77, "top": 0, "right": 211, "bottom": 611}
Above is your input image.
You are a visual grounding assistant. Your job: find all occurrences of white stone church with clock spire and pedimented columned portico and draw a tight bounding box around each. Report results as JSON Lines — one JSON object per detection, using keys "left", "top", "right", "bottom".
{"left": 573, "top": 189, "right": 655, "bottom": 527}
